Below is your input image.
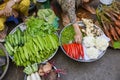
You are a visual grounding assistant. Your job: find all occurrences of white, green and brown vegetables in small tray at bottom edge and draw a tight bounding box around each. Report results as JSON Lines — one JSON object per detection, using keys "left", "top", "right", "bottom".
{"left": 24, "top": 62, "right": 58, "bottom": 80}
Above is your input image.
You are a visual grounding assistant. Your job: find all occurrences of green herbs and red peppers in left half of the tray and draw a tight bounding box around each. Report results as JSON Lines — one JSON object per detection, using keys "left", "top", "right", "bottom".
{"left": 61, "top": 25, "right": 84, "bottom": 60}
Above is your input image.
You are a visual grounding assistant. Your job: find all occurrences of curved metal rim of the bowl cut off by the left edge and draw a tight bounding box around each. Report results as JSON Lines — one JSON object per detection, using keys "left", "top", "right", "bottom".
{"left": 0, "top": 43, "right": 9, "bottom": 80}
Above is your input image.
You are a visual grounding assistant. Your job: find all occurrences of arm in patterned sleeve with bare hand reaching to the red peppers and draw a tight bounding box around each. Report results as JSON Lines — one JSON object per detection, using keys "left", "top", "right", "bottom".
{"left": 68, "top": 0, "right": 82, "bottom": 43}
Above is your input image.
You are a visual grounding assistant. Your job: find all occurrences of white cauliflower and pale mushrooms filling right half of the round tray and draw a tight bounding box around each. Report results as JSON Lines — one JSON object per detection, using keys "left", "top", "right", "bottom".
{"left": 82, "top": 18, "right": 109, "bottom": 60}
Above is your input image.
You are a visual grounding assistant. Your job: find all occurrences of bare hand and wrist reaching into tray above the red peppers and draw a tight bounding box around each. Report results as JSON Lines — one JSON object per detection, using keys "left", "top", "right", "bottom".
{"left": 73, "top": 23, "right": 82, "bottom": 43}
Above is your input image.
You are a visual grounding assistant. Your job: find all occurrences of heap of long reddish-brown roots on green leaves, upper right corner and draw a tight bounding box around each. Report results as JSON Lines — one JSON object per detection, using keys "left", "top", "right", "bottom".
{"left": 96, "top": 1, "right": 120, "bottom": 49}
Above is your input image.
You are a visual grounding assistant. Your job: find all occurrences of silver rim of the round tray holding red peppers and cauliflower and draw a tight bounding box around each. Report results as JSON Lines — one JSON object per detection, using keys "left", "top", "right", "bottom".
{"left": 59, "top": 21, "right": 106, "bottom": 62}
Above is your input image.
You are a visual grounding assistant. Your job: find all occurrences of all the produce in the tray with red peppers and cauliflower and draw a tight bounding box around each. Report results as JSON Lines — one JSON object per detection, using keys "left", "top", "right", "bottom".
{"left": 60, "top": 18, "right": 109, "bottom": 61}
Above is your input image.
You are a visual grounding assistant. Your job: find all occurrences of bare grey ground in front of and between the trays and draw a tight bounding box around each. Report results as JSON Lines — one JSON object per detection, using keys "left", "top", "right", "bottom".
{"left": 3, "top": 0, "right": 120, "bottom": 80}
